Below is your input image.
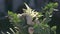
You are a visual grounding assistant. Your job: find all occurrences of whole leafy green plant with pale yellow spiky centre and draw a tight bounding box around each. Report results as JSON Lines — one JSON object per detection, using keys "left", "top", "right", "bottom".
{"left": 8, "top": 3, "right": 58, "bottom": 34}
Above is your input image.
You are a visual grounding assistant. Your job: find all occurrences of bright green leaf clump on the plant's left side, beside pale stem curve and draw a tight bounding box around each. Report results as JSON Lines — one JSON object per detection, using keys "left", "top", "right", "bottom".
{"left": 8, "top": 11, "right": 20, "bottom": 24}
